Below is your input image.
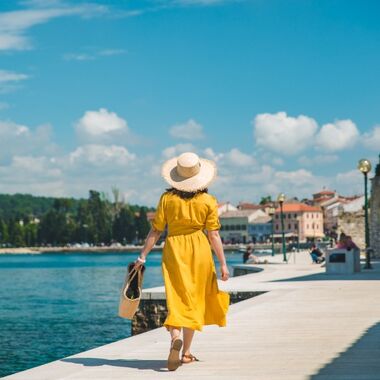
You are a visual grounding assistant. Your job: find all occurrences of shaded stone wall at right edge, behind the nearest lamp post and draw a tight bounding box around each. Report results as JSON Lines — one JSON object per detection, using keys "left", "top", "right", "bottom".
{"left": 369, "top": 173, "right": 380, "bottom": 258}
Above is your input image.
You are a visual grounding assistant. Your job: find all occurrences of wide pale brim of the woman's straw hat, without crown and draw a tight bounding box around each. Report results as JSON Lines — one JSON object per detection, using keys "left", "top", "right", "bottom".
{"left": 161, "top": 157, "right": 217, "bottom": 192}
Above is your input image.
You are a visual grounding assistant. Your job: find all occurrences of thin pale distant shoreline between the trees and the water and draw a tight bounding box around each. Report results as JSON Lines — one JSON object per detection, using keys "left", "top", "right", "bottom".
{"left": 0, "top": 245, "right": 243, "bottom": 255}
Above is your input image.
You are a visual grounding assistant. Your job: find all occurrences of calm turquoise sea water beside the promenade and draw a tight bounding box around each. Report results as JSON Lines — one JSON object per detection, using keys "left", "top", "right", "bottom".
{"left": 0, "top": 252, "right": 242, "bottom": 377}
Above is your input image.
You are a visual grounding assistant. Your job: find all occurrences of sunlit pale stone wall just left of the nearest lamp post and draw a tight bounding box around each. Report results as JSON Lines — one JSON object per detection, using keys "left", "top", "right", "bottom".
{"left": 337, "top": 210, "right": 365, "bottom": 249}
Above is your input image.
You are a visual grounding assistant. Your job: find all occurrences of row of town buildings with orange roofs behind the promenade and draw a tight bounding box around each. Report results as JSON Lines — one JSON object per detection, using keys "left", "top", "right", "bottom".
{"left": 219, "top": 190, "right": 364, "bottom": 244}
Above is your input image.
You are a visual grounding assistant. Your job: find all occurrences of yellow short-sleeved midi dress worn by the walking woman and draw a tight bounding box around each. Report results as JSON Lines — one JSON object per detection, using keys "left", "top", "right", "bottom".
{"left": 152, "top": 192, "right": 229, "bottom": 331}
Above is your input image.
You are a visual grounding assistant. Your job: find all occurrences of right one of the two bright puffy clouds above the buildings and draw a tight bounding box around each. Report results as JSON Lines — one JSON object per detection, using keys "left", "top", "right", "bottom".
{"left": 316, "top": 120, "right": 359, "bottom": 152}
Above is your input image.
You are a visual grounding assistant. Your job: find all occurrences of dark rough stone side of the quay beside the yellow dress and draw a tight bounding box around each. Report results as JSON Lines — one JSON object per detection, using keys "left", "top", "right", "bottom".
{"left": 132, "top": 291, "right": 266, "bottom": 335}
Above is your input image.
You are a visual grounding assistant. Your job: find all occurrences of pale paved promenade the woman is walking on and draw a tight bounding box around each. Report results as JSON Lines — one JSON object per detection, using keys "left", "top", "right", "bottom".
{"left": 4, "top": 252, "right": 380, "bottom": 380}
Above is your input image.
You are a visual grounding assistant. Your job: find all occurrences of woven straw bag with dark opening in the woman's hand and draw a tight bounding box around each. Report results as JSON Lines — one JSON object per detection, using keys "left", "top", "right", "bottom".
{"left": 119, "top": 267, "right": 145, "bottom": 319}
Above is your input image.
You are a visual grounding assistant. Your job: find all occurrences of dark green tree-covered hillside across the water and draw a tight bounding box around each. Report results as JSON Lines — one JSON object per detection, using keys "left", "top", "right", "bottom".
{"left": 0, "top": 189, "right": 152, "bottom": 247}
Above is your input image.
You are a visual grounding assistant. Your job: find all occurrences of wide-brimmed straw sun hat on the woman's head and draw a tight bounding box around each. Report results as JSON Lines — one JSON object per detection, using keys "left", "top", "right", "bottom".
{"left": 161, "top": 152, "right": 216, "bottom": 192}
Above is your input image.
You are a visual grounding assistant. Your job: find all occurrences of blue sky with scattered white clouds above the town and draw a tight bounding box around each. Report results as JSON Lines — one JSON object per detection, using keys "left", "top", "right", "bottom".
{"left": 0, "top": 0, "right": 380, "bottom": 204}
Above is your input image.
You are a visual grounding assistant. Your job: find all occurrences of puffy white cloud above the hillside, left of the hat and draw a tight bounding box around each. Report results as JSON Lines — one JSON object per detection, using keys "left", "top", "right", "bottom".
{"left": 75, "top": 108, "right": 129, "bottom": 144}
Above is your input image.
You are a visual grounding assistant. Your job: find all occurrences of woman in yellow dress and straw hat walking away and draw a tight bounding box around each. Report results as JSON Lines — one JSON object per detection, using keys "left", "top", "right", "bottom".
{"left": 135, "top": 153, "right": 229, "bottom": 371}
